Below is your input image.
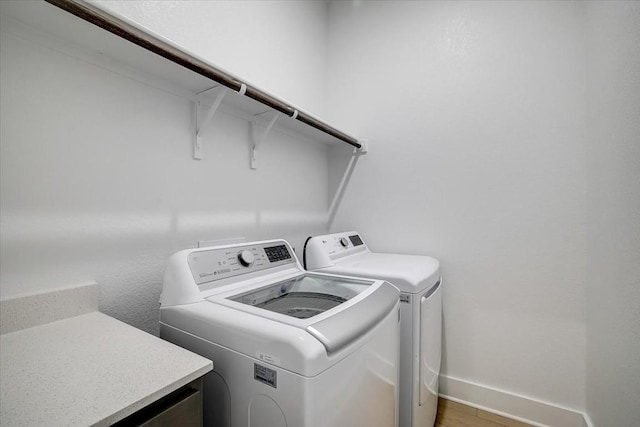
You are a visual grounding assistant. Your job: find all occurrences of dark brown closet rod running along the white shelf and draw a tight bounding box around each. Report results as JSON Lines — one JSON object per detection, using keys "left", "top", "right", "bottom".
{"left": 45, "top": 0, "right": 362, "bottom": 148}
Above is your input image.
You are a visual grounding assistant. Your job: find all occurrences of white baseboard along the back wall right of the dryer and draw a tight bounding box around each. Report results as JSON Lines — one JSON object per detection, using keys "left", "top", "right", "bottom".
{"left": 439, "top": 375, "right": 593, "bottom": 427}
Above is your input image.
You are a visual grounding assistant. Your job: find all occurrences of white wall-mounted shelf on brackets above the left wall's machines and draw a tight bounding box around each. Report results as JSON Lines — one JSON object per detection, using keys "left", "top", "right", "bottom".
{"left": 0, "top": 0, "right": 366, "bottom": 151}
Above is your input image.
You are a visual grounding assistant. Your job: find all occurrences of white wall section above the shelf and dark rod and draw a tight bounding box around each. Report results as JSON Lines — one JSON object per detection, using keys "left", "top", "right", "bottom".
{"left": 94, "top": 0, "right": 327, "bottom": 117}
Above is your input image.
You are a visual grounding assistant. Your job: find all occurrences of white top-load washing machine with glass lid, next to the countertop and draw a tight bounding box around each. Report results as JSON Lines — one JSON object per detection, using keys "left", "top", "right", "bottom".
{"left": 160, "top": 240, "right": 400, "bottom": 427}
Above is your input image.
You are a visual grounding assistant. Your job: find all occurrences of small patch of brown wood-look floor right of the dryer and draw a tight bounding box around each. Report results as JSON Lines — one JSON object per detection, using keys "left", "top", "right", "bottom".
{"left": 436, "top": 398, "right": 531, "bottom": 427}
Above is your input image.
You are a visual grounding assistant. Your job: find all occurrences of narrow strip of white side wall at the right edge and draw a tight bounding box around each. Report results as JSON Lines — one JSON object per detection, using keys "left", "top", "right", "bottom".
{"left": 587, "top": 2, "right": 640, "bottom": 426}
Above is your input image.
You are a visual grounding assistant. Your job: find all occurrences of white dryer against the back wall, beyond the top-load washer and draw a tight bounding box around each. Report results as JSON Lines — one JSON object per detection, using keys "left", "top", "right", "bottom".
{"left": 305, "top": 232, "right": 442, "bottom": 427}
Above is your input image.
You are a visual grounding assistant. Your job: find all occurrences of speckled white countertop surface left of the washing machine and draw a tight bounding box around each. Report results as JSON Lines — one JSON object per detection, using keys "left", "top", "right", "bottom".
{"left": 0, "top": 311, "right": 213, "bottom": 427}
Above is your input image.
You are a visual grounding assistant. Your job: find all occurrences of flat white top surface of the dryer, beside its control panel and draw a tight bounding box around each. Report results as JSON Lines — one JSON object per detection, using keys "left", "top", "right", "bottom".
{"left": 318, "top": 252, "right": 440, "bottom": 294}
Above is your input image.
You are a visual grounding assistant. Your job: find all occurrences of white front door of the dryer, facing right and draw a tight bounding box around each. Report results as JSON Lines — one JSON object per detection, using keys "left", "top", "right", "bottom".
{"left": 419, "top": 280, "right": 442, "bottom": 414}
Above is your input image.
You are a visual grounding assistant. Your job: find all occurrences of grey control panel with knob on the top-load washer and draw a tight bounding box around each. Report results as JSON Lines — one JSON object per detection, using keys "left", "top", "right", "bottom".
{"left": 188, "top": 241, "right": 296, "bottom": 285}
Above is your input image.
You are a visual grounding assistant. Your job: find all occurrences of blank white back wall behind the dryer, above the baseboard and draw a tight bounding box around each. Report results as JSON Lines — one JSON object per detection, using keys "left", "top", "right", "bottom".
{"left": 327, "top": 2, "right": 586, "bottom": 409}
